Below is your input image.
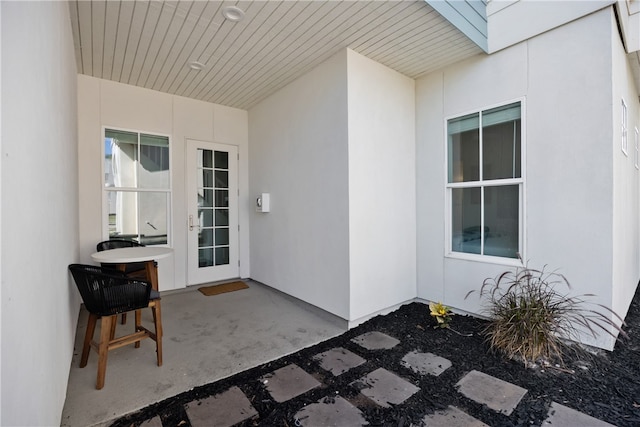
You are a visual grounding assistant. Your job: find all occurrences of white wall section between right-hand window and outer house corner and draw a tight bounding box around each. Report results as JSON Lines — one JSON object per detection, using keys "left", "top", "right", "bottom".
{"left": 527, "top": 8, "right": 624, "bottom": 348}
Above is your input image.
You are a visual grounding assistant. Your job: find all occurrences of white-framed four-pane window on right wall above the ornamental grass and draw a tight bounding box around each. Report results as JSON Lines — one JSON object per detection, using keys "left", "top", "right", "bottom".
{"left": 447, "top": 102, "right": 523, "bottom": 258}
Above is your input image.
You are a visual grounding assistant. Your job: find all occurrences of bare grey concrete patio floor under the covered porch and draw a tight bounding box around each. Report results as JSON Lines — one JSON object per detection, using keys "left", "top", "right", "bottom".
{"left": 61, "top": 280, "right": 347, "bottom": 427}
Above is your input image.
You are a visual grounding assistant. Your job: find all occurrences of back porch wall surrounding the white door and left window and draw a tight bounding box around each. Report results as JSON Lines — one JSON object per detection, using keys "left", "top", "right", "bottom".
{"left": 78, "top": 75, "right": 253, "bottom": 290}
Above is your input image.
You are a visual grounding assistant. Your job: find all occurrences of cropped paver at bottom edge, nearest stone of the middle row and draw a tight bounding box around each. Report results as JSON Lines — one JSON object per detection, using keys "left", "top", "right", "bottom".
{"left": 295, "top": 396, "right": 369, "bottom": 427}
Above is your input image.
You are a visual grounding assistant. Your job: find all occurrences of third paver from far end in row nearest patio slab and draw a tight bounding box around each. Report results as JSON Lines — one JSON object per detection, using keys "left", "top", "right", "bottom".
{"left": 260, "top": 363, "right": 320, "bottom": 402}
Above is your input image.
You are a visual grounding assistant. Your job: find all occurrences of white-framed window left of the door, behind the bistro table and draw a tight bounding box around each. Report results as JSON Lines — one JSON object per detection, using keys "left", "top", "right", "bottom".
{"left": 104, "top": 129, "right": 171, "bottom": 245}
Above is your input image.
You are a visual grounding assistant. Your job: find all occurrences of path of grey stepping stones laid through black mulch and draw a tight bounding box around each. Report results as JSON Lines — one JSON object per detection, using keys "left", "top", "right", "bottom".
{"left": 175, "top": 331, "right": 611, "bottom": 427}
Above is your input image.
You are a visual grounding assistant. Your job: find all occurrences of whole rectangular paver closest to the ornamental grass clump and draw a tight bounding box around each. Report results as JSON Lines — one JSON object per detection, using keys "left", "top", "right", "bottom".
{"left": 456, "top": 371, "right": 527, "bottom": 415}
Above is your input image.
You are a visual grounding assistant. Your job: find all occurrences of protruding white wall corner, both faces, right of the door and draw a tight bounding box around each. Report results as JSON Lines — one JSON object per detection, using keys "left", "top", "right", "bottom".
{"left": 249, "top": 50, "right": 416, "bottom": 324}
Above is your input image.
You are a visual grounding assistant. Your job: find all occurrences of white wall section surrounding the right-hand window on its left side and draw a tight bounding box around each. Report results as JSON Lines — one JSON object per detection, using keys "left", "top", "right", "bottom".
{"left": 416, "top": 44, "right": 527, "bottom": 312}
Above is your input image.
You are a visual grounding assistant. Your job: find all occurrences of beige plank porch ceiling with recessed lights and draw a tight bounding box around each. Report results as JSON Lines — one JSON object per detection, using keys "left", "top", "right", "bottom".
{"left": 69, "top": 0, "right": 481, "bottom": 109}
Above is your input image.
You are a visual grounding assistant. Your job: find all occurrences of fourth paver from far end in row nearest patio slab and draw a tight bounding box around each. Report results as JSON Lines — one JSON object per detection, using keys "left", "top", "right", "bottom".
{"left": 185, "top": 386, "right": 258, "bottom": 427}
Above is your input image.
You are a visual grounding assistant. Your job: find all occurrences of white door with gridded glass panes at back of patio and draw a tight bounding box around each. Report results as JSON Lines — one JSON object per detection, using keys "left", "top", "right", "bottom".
{"left": 186, "top": 140, "right": 240, "bottom": 285}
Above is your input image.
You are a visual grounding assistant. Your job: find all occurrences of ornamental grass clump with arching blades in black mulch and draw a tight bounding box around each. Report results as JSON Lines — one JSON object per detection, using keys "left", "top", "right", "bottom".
{"left": 467, "top": 263, "right": 625, "bottom": 366}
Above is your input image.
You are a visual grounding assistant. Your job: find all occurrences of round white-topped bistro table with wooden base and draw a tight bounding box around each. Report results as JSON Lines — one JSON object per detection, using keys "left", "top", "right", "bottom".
{"left": 91, "top": 246, "right": 173, "bottom": 291}
